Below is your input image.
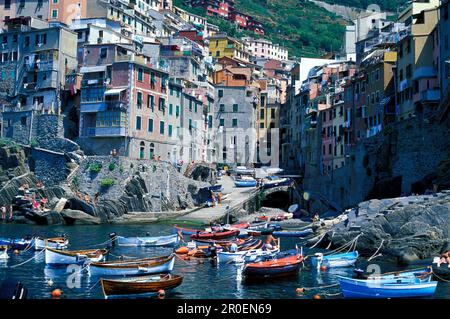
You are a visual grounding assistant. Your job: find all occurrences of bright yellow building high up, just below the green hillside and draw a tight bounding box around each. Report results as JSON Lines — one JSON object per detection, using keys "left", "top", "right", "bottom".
{"left": 209, "top": 35, "right": 250, "bottom": 62}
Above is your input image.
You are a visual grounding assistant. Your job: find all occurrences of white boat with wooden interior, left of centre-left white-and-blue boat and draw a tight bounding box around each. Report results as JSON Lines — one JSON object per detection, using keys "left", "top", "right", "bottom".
{"left": 45, "top": 247, "right": 108, "bottom": 266}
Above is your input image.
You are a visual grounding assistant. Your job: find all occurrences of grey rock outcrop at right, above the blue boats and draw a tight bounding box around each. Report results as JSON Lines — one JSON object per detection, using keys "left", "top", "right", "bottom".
{"left": 321, "top": 191, "right": 450, "bottom": 264}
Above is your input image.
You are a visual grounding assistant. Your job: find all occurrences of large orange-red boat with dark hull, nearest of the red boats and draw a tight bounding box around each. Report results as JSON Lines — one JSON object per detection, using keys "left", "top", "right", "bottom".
{"left": 243, "top": 251, "right": 304, "bottom": 277}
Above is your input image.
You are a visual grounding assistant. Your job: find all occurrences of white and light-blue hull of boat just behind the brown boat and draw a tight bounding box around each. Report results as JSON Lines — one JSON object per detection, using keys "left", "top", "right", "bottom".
{"left": 88, "top": 255, "right": 175, "bottom": 276}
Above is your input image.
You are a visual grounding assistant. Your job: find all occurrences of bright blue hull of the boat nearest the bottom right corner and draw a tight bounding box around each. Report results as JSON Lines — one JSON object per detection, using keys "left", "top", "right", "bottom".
{"left": 339, "top": 277, "right": 437, "bottom": 298}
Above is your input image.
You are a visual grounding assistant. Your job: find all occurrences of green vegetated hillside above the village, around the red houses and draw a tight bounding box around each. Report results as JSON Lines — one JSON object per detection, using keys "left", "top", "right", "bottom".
{"left": 174, "top": 0, "right": 346, "bottom": 57}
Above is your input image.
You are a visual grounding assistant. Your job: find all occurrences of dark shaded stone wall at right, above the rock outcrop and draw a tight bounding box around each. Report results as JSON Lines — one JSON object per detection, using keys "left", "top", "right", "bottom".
{"left": 303, "top": 117, "right": 450, "bottom": 212}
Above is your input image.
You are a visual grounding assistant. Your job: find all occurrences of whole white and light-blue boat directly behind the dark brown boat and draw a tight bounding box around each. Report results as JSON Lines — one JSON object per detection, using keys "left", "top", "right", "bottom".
{"left": 88, "top": 254, "right": 175, "bottom": 276}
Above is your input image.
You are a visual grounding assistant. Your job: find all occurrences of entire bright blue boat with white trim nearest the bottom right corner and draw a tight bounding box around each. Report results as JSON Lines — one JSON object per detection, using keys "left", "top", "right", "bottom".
{"left": 337, "top": 270, "right": 437, "bottom": 298}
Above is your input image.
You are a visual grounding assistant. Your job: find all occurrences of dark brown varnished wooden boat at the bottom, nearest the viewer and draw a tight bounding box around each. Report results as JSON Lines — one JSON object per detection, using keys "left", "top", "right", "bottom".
{"left": 100, "top": 274, "right": 183, "bottom": 298}
